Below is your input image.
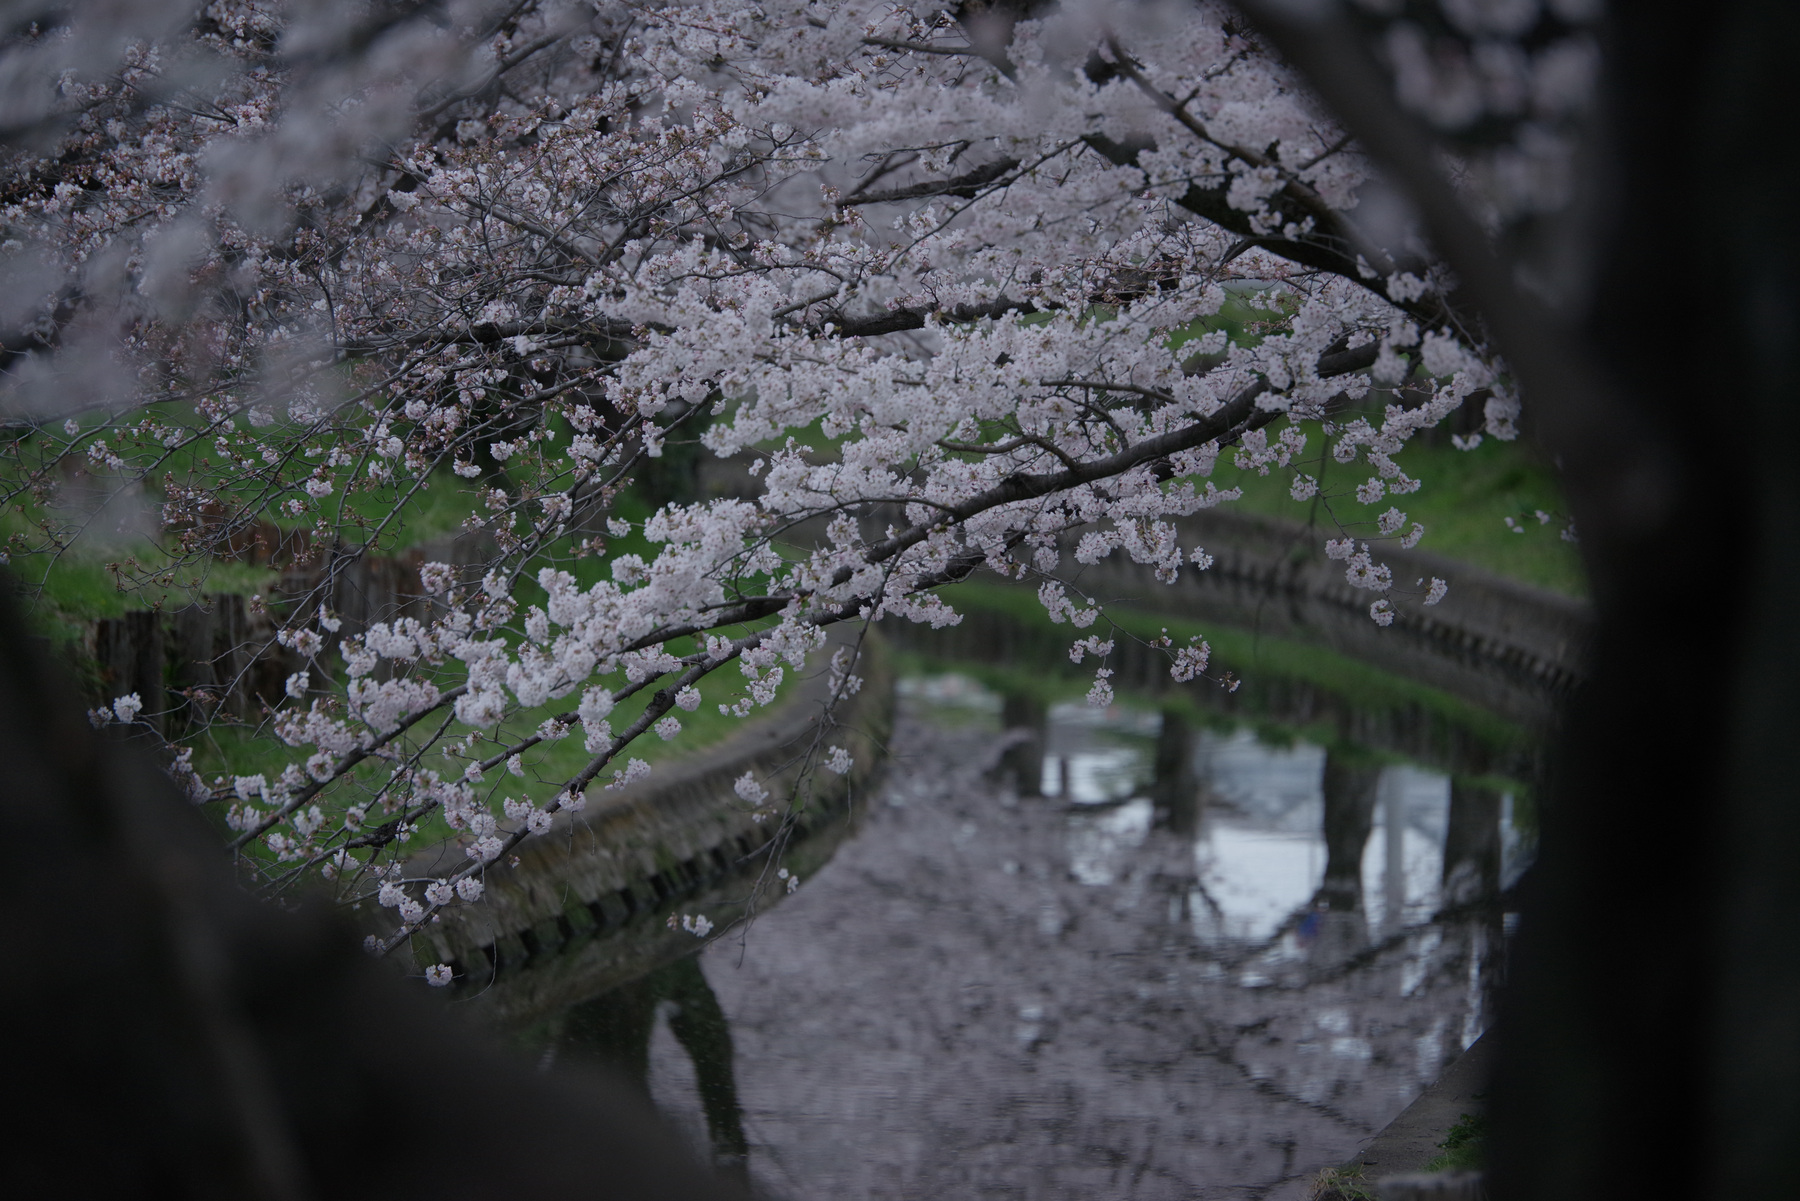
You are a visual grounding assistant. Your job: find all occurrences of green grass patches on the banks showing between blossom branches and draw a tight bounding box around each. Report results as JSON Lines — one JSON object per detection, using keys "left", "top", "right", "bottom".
{"left": 21, "top": 297, "right": 1582, "bottom": 831}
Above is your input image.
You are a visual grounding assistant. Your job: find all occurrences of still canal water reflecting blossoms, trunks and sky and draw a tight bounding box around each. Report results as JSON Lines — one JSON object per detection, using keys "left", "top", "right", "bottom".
{"left": 542, "top": 673, "right": 1528, "bottom": 1201}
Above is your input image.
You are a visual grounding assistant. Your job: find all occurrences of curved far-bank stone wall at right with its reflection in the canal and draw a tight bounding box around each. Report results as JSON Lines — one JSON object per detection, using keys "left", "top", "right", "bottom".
{"left": 884, "top": 513, "right": 1589, "bottom": 783}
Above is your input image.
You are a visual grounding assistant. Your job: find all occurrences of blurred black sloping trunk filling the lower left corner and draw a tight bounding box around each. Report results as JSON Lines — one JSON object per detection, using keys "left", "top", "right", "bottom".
{"left": 0, "top": 579, "right": 742, "bottom": 1201}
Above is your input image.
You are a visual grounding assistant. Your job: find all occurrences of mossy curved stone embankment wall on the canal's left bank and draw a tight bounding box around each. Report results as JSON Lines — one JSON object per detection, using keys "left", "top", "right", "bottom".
{"left": 392, "top": 628, "right": 895, "bottom": 1025}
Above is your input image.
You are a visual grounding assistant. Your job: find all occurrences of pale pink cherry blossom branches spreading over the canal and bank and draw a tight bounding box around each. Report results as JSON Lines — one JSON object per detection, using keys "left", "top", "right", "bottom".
{"left": 5, "top": 4, "right": 1526, "bottom": 947}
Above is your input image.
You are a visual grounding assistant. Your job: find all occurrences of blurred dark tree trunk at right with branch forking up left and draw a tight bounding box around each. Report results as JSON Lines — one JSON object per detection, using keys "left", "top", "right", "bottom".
{"left": 1265, "top": 0, "right": 1800, "bottom": 1201}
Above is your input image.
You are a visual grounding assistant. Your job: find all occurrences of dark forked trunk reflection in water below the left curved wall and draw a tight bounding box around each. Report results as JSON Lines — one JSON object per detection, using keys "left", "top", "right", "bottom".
{"left": 563, "top": 954, "right": 749, "bottom": 1172}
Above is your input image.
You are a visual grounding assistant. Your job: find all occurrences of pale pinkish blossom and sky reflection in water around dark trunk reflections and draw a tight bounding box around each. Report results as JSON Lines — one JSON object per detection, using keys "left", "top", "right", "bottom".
{"left": 650, "top": 705, "right": 1504, "bottom": 1201}
